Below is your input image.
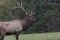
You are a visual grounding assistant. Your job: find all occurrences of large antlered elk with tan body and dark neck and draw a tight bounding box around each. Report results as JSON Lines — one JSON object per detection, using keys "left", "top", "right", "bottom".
{"left": 0, "top": 2, "right": 36, "bottom": 40}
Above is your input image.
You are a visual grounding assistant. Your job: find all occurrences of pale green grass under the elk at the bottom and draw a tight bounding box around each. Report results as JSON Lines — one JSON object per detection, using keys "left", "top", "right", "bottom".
{"left": 4, "top": 32, "right": 60, "bottom": 40}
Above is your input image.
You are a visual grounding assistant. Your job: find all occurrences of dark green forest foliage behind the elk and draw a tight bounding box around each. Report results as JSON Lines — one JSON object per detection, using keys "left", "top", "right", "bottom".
{"left": 0, "top": 0, "right": 60, "bottom": 33}
